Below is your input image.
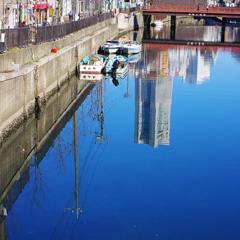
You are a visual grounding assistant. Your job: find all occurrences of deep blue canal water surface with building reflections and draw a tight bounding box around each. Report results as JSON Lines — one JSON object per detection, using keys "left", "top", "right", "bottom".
{"left": 0, "top": 25, "right": 240, "bottom": 240}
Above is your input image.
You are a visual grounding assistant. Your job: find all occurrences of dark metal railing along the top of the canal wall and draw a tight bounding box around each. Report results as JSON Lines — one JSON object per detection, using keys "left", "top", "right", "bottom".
{"left": 0, "top": 12, "right": 112, "bottom": 53}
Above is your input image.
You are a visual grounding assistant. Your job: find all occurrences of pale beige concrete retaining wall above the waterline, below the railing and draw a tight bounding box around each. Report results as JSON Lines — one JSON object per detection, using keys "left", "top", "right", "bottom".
{"left": 0, "top": 20, "right": 118, "bottom": 143}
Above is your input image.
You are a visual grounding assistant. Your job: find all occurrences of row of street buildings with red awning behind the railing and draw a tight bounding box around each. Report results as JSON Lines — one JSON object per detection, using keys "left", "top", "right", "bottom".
{"left": 0, "top": 0, "right": 120, "bottom": 28}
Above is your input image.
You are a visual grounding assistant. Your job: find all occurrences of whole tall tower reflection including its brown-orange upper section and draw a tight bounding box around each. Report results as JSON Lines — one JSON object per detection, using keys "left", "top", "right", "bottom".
{"left": 135, "top": 49, "right": 173, "bottom": 147}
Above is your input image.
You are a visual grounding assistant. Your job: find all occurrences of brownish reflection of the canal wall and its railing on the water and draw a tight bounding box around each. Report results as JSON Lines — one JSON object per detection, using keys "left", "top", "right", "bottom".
{"left": 0, "top": 77, "right": 92, "bottom": 206}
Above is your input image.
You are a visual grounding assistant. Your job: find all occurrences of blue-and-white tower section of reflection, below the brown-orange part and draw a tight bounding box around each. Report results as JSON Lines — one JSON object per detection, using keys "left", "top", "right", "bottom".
{"left": 135, "top": 77, "right": 173, "bottom": 147}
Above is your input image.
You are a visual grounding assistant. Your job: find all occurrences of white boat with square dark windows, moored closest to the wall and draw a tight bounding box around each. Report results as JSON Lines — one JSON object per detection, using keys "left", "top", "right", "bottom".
{"left": 79, "top": 54, "right": 107, "bottom": 74}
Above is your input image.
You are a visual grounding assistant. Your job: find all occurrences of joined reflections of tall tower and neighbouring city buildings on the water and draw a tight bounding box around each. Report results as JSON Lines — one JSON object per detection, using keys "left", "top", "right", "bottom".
{"left": 135, "top": 44, "right": 217, "bottom": 148}
